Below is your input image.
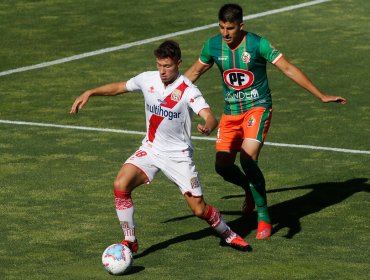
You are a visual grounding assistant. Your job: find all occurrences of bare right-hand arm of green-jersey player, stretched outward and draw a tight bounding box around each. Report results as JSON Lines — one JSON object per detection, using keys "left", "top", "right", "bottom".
{"left": 275, "top": 56, "right": 346, "bottom": 104}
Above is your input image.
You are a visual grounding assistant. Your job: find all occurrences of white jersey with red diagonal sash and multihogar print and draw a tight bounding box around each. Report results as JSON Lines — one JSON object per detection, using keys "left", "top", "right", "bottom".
{"left": 126, "top": 71, "right": 209, "bottom": 157}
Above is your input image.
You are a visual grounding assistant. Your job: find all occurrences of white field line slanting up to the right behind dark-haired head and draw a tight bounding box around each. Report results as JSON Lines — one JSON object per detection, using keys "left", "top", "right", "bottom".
{"left": 0, "top": 0, "right": 331, "bottom": 76}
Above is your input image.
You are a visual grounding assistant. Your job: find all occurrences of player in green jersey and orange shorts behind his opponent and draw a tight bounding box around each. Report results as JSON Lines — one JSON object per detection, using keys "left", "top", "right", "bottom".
{"left": 185, "top": 4, "right": 346, "bottom": 239}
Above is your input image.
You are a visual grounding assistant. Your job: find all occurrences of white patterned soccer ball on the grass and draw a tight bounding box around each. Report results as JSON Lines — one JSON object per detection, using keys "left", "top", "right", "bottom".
{"left": 102, "top": 244, "right": 133, "bottom": 275}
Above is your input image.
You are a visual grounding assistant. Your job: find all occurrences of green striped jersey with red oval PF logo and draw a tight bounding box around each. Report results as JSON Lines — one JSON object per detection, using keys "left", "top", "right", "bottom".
{"left": 199, "top": 32, "right": 282, "bottom": 115}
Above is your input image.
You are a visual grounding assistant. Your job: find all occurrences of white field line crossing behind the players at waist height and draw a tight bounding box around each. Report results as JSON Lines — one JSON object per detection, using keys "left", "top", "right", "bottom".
{"left": 0, "top": 120, "right": 370, "bottom": 154}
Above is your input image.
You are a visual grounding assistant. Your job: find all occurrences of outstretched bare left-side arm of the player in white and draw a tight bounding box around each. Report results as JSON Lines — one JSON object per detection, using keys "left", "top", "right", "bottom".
{"left": 69, "top": 82, "right": 128, "bottom": 114}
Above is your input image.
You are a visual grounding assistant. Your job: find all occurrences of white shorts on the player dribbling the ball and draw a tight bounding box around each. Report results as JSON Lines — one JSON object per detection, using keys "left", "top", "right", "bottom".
{"left": 125, "top": 146, "right": 203, "bottom": 197}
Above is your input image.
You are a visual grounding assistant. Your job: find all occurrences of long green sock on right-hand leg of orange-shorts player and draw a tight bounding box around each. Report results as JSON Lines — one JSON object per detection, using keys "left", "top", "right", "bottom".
{"left": 240, "top": 159, "right": 271, "bottom": 223}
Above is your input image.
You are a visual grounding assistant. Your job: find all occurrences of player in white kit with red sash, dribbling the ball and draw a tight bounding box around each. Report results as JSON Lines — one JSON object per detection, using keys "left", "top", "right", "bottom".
{"left": 70, "top": 40, "right": 252, "bottom": 252}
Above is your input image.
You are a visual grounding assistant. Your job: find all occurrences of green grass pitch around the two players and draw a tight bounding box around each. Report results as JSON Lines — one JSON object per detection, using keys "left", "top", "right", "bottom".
{"left": 0, "top": 0, "right": 370, "bottom": 280}
